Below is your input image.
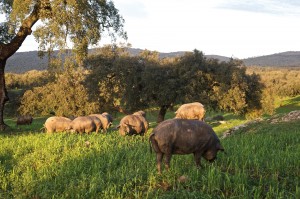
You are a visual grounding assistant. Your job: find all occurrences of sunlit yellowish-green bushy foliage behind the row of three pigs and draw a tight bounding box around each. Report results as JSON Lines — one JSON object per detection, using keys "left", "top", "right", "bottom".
{"left": 19, "top": 63, "right": 98, "bottom": 116}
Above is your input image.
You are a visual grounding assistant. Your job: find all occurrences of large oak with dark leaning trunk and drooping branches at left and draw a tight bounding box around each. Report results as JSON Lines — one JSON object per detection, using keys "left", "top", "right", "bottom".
{"left": 0, "top": 0, "right": 127, "bottom": 130}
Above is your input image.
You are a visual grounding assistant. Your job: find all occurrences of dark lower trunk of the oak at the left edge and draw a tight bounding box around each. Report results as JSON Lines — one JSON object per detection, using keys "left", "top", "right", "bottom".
{"left": 0, "top": 60, "right": 8, "bottom": 131}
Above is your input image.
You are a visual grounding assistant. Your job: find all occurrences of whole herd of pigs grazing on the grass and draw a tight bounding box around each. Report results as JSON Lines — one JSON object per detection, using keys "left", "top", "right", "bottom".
{"left": 17, "top": 102, "right": 224, "bottom": 173}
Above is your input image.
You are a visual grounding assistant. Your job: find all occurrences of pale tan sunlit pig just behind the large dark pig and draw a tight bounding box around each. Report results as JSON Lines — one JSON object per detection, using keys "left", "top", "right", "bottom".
{"left": 175, "top": 102, "right": 205, "bottom": 121}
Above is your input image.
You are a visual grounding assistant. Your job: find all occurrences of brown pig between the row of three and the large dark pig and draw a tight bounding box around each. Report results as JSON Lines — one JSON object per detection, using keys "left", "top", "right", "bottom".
{"left": 117, "top": 114, "right": 149, "bottom": 136}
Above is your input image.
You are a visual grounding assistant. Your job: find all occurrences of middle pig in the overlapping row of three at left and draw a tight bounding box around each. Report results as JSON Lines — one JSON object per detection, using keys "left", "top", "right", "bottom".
{"left": 71, "top": 116, "right": 98, "bottom": 134}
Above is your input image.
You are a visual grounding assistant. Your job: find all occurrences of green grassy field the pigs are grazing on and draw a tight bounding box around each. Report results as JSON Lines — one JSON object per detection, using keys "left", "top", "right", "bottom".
{"left": 0, "top": 96, "right": 300, "bottom": 199}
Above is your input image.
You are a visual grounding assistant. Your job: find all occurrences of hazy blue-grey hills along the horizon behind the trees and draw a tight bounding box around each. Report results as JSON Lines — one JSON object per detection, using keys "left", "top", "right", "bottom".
{"left": 5, "top": 48, "right": 300, "bottom": 73}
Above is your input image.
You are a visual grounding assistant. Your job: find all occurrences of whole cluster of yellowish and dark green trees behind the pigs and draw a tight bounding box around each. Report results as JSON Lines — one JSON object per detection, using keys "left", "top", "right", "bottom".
{"left": 16, "top": 46, "right": 263, "bottom": 122}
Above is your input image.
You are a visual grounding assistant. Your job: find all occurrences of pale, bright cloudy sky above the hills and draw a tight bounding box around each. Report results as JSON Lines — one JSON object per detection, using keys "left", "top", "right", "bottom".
{"left": 1, "top": 0, "right": 300, "bottom": 59}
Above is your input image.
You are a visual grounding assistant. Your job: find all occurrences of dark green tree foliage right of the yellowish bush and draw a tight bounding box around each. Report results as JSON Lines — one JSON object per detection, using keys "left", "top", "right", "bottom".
{"left": 87, "top": 46, "right": 262, "bottom": 118}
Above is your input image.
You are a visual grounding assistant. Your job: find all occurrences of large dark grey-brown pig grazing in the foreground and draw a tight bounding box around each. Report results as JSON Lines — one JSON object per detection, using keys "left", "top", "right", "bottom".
{"left": 149, "top": 118, "right": 224, "bottom": 173}
